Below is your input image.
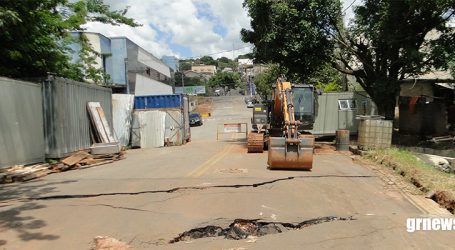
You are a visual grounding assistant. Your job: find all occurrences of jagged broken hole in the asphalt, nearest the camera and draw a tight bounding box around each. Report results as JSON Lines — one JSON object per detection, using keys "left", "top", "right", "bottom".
{"left": 169, "top": 216, "right": 355, "bottom": 244}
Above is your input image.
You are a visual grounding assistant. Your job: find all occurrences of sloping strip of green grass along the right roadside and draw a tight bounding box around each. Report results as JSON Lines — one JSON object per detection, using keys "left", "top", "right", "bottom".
{"left": 364, "top": 148, "right": 455, "bottom": 204}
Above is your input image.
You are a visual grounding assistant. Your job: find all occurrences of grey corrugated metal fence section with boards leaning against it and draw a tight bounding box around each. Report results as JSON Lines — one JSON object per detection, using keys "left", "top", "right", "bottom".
{"left": 43, "top": 78, "right": 112, "bottom": 158}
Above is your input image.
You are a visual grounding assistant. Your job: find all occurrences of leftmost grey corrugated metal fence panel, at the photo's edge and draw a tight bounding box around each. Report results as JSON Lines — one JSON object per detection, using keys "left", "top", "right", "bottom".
{"left": 0, "top": 77, "right": 44, "bottom": 167}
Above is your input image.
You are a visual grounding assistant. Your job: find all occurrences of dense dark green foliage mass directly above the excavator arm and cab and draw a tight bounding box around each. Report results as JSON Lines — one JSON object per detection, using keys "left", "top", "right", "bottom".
{"left": 241, "top": 0, "right": 341, "bottom": 80}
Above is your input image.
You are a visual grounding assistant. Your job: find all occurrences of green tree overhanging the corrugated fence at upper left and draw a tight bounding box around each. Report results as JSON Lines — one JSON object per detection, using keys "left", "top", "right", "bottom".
{"left": 0, "top": 0, "right": 138, "bottom": 79}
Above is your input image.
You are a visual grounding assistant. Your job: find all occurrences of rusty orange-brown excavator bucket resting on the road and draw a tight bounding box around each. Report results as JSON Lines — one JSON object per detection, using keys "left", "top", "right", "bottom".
{"left": 268, "top": 135, "right": 314, "bottom": 170}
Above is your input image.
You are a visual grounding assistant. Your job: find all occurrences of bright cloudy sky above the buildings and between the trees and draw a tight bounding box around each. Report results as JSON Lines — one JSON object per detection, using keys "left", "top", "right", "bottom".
{"left": 85, "top": 0, "right": 361, "bottom": 59}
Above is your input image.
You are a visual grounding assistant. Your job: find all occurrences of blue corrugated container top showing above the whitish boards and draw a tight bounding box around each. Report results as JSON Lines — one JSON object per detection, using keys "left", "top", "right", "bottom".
{"left": 134, "top": 94, "right": 183, "bottom": 109}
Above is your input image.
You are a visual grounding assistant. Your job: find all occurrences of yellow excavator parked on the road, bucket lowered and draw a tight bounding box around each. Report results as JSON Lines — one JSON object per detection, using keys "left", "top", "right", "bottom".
{"left": 247, "top": 78, "right": 316, "bottom": 170}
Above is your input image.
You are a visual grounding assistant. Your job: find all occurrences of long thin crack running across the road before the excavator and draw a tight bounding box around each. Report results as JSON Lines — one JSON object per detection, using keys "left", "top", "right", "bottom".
{"left": 31, "top": 175, "right": 377, "bottom": 201}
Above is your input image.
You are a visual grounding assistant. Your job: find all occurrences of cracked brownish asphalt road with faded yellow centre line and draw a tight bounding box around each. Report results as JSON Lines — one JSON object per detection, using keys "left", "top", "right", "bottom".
{"left": 0, "top": 96, "right": 455, "bottom": 249}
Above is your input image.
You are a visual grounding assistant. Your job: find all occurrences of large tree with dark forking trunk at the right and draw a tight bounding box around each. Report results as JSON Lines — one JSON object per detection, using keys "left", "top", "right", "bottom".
{"left": 334, "top": 0, "right": 455, "bottom": 119}
